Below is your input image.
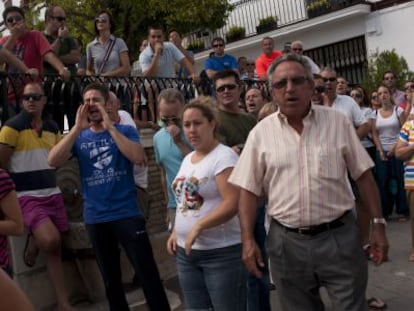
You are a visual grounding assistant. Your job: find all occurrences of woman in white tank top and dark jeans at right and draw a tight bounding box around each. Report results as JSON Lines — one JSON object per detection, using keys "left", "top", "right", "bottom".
{"left": 372, "top": 86, "right": 409, "bottom": 221}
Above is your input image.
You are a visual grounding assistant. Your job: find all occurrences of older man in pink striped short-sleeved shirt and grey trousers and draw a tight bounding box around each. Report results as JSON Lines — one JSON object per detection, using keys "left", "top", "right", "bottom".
{"left": 229, "top": 54, "right": 388, "bottom": 310}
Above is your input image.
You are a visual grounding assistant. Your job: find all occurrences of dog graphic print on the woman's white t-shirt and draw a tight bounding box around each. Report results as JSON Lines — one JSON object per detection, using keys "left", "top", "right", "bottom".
{"left": 172, "top": 176, "right": 207, "bottom": 213}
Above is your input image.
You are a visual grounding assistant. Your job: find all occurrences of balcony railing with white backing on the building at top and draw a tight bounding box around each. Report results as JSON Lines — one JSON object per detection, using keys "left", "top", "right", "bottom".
{"left": 188, "top": 0, "right": 371, "bottom": 49}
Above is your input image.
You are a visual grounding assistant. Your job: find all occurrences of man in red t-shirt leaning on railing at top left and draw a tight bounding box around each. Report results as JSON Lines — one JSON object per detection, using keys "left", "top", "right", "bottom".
{"left": 0, "top": 6, "right": 70, "bottom": 114}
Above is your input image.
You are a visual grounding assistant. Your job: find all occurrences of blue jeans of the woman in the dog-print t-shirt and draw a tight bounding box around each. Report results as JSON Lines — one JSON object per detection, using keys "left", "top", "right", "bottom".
{"left": 177, "top": 244, "right": 247, "bottom": 311}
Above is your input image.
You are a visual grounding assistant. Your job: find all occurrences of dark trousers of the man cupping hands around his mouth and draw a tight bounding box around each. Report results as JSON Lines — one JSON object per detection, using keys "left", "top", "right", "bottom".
{"left": 86, "top": 216, "right": 170, "bottom": 311}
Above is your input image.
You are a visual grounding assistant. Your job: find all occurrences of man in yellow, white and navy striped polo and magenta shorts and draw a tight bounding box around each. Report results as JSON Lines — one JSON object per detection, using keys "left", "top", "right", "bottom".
{"left": 0, "top": 82, "right": 73, "bottom": 310}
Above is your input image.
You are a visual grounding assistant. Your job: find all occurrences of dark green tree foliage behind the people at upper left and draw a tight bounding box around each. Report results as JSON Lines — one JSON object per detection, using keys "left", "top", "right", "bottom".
{"left": 25, "top": 0, "right": 232, "bottom": 60}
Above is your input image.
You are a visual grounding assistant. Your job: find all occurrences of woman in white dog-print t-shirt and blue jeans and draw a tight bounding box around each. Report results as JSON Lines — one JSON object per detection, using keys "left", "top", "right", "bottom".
{"left": 167, "top": 97, "right": 246, "bottom": 311}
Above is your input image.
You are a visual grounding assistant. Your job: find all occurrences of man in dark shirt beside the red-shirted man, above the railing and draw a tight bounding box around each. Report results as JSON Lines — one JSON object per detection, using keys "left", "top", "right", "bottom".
{"left": 43, "top": 6, "right": 81, "bottom": 76}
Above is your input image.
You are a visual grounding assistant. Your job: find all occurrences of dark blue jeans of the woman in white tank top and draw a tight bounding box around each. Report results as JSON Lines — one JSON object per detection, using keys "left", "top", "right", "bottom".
{"left": 375, "top": 150, "right": 409, "bottom": 217}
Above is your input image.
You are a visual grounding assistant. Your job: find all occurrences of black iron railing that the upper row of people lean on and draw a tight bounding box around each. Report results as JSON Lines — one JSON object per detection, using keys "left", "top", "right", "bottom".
{"left": 0, "top": 74, "right": 268, "bottom": 131}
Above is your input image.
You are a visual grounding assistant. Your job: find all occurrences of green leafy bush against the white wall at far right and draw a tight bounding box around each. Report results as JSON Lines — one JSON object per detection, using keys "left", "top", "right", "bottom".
{"left": 362, "top": 49, "right": 414, "bottom": 92}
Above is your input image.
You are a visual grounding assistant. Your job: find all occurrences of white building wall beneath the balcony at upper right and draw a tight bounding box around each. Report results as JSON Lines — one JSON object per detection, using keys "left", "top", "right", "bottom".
{"left": 196, "top": 1, "right": 414, "bottom": 71}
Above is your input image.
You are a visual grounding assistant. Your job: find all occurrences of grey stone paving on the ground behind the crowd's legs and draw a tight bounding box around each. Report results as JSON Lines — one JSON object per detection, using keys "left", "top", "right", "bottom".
{"left": 80, "top": 221, "right": 414, "bottom": 311}
